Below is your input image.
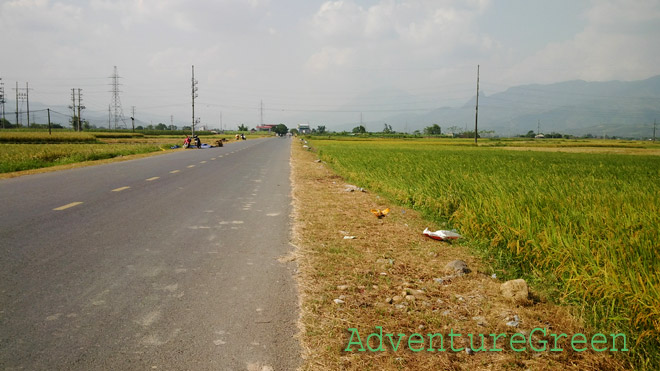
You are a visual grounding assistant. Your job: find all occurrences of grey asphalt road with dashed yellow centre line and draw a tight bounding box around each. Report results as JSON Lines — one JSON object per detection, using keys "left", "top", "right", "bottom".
{"left": 0, "top": 138, "right": 300, "bottom": 371}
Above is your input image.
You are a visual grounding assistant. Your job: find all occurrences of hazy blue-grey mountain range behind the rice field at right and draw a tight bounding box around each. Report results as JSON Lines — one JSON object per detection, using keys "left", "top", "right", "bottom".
{"left": 339, "top": 76, "right": 660, "bottom": 138}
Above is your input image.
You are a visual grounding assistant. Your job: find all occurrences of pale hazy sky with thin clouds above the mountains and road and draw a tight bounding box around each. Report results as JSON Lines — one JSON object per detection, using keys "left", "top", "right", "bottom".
{"left": 0, "top": 0, "right": 660, "bottom": 128}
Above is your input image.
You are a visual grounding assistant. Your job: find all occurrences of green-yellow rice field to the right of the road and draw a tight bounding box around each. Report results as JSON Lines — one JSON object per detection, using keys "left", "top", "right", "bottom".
{"left": 310, "top": 139, "right": 660, "bottom": 366}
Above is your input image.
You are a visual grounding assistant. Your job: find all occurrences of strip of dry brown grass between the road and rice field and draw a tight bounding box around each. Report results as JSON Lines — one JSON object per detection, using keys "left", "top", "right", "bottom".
{"left": 291, "top": 140, "right": 630, "bottom": 370}
